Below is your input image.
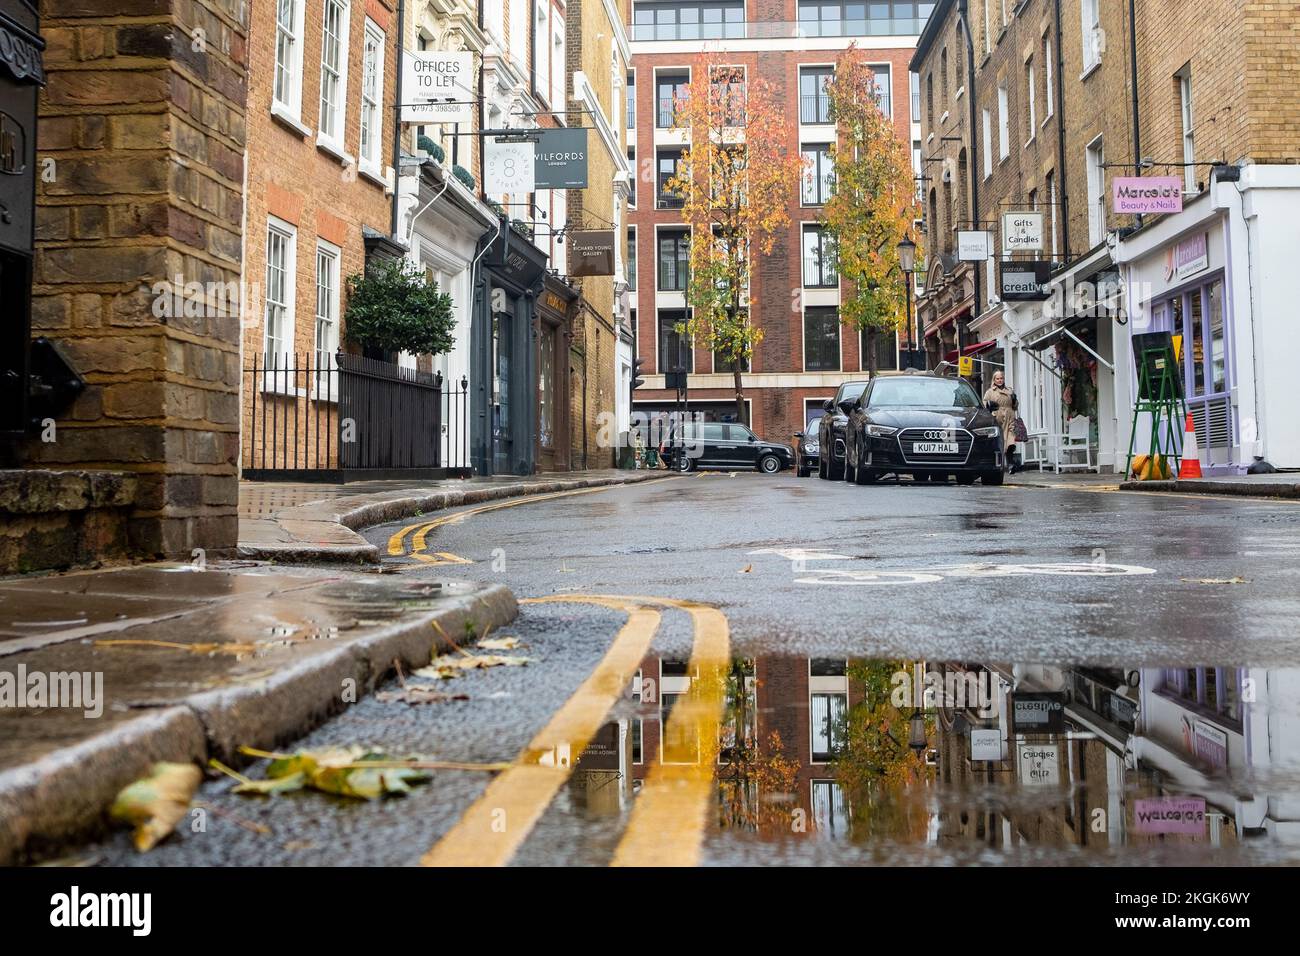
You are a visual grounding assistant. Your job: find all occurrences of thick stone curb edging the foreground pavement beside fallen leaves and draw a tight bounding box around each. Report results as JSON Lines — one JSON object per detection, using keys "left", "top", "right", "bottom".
{"left": 0, "top": 584, "right": 519, "bottom": 866}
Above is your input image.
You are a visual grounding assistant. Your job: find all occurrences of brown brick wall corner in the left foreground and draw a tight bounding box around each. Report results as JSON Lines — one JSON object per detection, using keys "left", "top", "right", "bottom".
{"left": 29, "top": 0, "right": 248, "bottom": 555}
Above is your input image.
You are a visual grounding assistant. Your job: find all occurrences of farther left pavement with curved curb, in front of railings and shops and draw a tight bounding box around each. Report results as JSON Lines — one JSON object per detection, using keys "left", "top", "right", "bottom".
{"left": 239, "top": 468, "right": 657, "bottom": 563}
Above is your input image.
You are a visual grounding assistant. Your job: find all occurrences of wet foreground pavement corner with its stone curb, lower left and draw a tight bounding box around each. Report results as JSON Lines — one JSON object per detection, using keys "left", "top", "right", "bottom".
{"left": 0, "top": 564, "right": 516, "bottom": 865}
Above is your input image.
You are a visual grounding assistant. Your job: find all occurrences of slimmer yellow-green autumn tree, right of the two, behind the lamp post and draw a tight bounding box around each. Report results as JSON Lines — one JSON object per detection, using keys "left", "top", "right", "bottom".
{"left": 822, "top": 46, "right": 920, "bottom": 373}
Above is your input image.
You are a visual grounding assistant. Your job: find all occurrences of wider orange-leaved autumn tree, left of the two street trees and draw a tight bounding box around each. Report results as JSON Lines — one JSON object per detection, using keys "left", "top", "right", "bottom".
{"left": 663, "top": 56, "right": 802, "bottom": 423}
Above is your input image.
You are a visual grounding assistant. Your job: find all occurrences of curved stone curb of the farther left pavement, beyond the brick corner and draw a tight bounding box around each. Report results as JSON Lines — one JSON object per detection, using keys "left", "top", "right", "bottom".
{"left": 239, "top": 471, "right": 671, "bottom": 563}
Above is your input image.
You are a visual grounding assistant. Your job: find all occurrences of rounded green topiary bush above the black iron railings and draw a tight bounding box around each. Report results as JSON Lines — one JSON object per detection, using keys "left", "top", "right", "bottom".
{"left": 343, "top": 259, "right": 456, "bottom": 362}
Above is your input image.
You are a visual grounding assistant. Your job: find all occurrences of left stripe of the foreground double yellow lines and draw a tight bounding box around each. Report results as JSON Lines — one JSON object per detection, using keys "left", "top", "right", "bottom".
{"left": 420, "top": 596, "right": 660, "bottom": 866}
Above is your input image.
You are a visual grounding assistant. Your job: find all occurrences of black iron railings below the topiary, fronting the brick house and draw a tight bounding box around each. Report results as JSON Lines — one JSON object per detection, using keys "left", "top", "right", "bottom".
{"left": 242, "top": 352, "right": 469, "bottom": 481}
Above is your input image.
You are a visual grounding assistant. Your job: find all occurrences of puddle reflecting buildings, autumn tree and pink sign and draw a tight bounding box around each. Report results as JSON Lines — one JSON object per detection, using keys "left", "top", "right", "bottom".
{"left": 569, "top": 657, "right": 1300, "bottom": 865}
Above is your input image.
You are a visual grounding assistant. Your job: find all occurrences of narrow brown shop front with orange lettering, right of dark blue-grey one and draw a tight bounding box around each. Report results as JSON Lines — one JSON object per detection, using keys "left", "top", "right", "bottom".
{"left": 537, "top": 273, "right": 579, "bottom": 471}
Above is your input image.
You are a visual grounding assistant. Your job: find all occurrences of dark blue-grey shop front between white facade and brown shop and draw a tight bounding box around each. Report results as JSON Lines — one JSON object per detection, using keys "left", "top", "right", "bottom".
{"left": 469, "top": 228, "right": 546, "bottom": 475}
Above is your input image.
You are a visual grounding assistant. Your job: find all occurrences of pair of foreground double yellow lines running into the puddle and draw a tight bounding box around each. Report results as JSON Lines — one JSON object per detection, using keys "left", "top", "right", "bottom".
{"left": 420, "top": 594, "right": 731, "bottom": 866}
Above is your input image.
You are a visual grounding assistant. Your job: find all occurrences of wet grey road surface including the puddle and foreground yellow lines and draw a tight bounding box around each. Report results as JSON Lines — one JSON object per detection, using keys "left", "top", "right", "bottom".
{"left": 65, "top": 473, "right": 1300, "bottom": 865}
